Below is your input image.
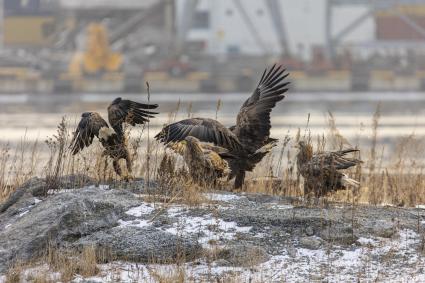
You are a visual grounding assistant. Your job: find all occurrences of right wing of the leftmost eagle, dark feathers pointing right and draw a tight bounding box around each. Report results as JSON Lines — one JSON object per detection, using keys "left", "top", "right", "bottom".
{"left": 108, "top": 97, "right": 158, "bottom": 137}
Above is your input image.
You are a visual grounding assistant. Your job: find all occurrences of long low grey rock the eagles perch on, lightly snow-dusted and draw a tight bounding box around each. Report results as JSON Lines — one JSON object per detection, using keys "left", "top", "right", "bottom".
{"left": 0, "top": 176, "right": 425, "bottom": 278}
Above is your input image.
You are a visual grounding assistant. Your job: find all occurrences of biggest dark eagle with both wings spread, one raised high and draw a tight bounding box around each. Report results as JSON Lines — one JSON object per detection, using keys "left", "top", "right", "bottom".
{"left": 155, "top": 64, "right": 289, "bottom": 189}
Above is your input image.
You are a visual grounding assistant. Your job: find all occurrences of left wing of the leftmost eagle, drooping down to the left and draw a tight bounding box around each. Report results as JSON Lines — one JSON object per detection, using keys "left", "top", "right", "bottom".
{"left": 70, "top": 112, "right": 109, "bottom": 154}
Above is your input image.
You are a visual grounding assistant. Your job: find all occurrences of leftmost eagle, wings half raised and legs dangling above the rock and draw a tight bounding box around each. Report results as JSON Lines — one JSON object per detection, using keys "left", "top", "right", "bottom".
{"left": 70, "top": 97, "right": 158, "bottom": 176}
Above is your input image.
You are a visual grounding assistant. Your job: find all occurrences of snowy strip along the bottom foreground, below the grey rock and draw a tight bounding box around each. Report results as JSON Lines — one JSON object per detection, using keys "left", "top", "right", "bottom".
{"left": 66, "top": 230, "right": 425, "bottom": 282}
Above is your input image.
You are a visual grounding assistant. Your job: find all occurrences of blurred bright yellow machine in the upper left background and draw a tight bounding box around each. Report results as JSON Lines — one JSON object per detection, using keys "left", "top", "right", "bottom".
{"left": 69, "top": 23, "right": 123, "bottom": 77}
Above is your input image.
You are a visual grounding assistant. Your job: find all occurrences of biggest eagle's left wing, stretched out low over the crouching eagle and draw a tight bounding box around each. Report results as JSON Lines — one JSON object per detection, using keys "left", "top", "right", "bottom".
{"left": 155, "top": 118, "right": 242, "bottom": 151}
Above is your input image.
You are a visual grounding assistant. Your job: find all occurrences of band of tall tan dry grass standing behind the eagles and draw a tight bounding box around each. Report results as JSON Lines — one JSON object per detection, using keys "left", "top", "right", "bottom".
{"left": 0, "top": 101, "right": 425, "bottom": 209}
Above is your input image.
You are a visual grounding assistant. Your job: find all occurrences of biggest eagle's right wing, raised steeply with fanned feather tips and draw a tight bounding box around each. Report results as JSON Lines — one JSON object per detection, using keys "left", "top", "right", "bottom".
{"left": 231, "top": 65, "right": 289, "bottom": 153}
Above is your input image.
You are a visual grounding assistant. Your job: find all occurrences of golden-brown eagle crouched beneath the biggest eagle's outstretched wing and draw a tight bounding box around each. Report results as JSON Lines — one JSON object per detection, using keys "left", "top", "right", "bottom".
{"left": 169, "top": 136, "right": 234, "bottom": 185}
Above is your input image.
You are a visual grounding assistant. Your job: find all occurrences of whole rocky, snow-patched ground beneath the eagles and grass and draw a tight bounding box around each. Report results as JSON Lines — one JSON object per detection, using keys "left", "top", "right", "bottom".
{"left": 0, "top": 176, "right": 425, "bottom": 282}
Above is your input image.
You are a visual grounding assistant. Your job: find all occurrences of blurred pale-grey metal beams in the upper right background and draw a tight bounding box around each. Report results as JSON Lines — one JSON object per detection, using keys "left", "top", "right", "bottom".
{"left": 325, "top": 0, "right": 425, "bottom": 59}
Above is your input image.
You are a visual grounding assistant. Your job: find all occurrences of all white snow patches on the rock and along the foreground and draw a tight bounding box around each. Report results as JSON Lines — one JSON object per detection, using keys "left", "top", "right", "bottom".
{"left": 0, "top": 190, "right": 425, "bottom": 282}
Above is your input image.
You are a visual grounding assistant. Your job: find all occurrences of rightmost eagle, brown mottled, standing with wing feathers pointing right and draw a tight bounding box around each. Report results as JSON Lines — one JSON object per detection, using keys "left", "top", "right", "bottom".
{"left": 296, "top": 141, "right": 362, "bottom": 197}
